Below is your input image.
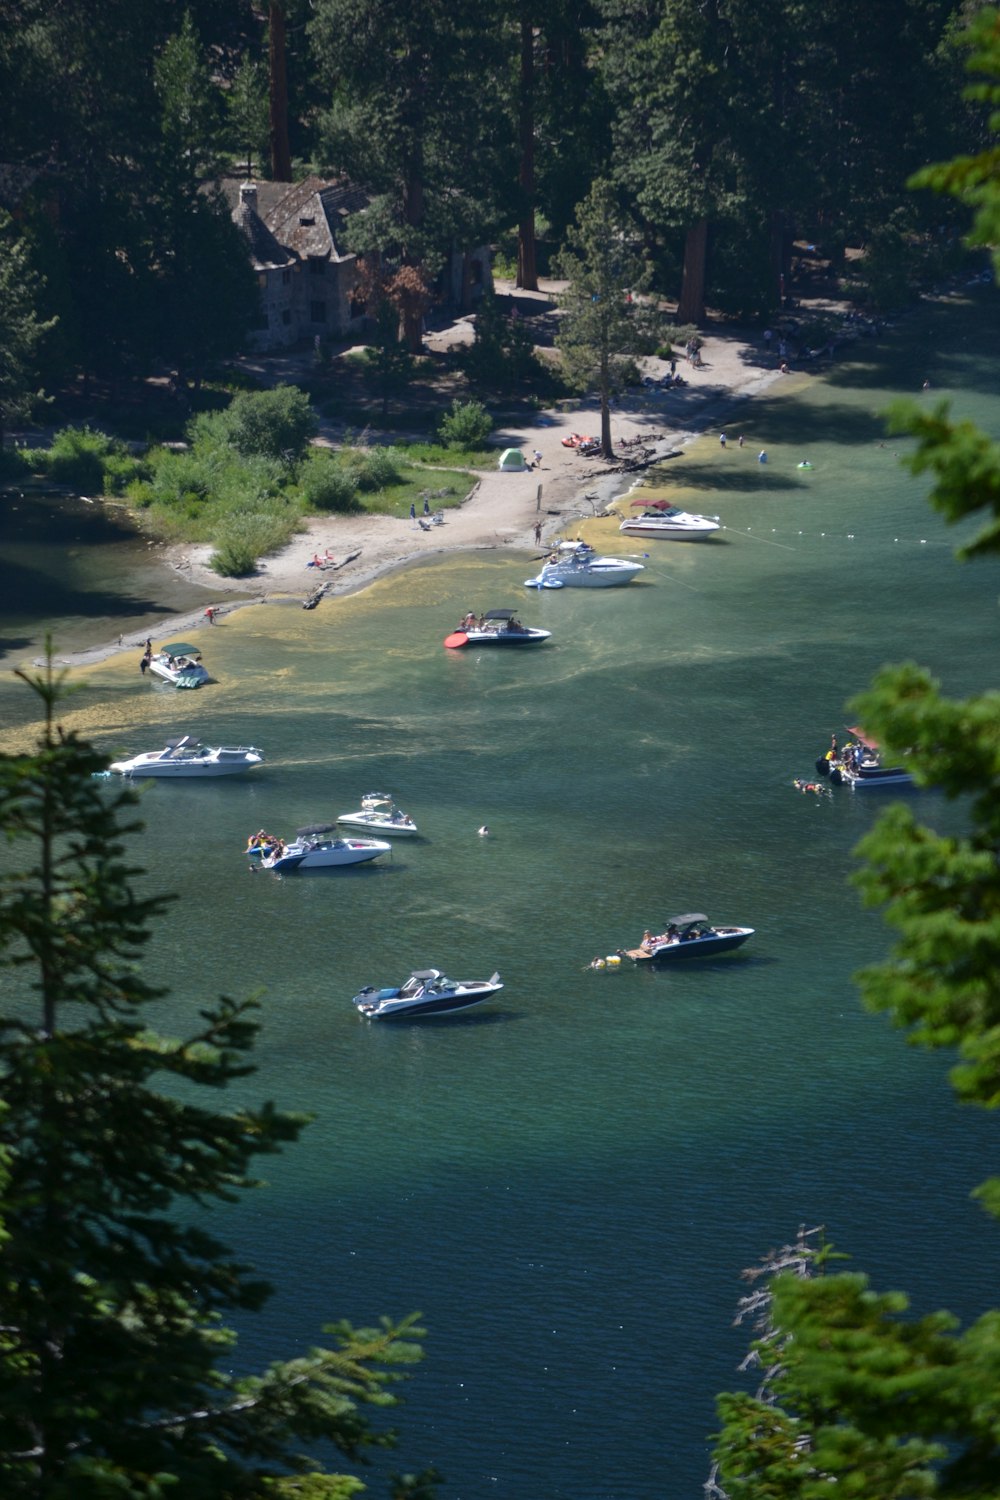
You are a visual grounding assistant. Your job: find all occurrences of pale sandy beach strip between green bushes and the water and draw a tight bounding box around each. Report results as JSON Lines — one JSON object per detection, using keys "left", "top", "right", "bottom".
{"left": 50, "top": 318, "right": 783, "bottom": 666}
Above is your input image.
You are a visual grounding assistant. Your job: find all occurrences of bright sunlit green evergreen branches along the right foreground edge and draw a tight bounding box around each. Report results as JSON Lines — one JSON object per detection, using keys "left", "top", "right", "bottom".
{"left": 712, "top": 9, "right": 1000, "bottom": 1500}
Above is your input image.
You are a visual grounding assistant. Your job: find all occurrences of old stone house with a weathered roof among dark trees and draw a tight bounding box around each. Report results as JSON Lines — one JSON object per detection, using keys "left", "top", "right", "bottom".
{"left": 223, "top": 177, "right": 492, "bottom": 353}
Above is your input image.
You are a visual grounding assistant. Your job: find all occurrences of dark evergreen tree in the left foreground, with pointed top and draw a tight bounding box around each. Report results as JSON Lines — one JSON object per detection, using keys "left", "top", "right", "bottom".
{"left": 0, "top": 666, "right": 417, "bottom": 1500}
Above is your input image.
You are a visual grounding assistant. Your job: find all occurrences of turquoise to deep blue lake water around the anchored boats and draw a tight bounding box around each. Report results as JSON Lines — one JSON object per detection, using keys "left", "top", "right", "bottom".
{"left": 0, "top": 289, "right": 1000, "bottom": 1500}
